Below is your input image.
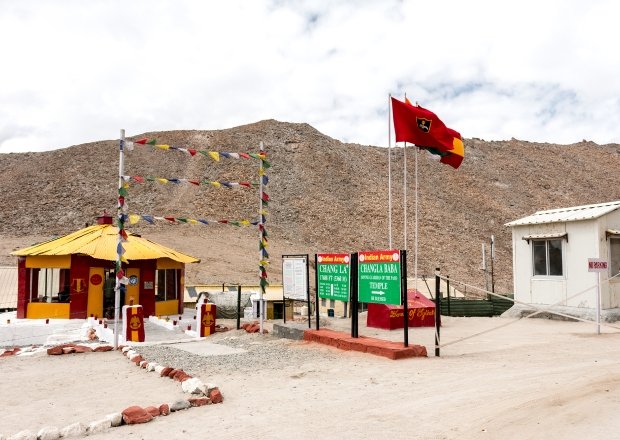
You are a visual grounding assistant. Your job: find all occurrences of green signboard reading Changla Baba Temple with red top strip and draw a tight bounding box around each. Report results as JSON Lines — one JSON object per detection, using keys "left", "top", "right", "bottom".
{"left": 357, "top": 250, "right": 401, "bottom": 304}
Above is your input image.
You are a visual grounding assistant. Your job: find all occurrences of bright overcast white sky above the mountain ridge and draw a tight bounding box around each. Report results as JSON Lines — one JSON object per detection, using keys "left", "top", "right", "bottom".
{"left": 0, "top": 0, "right": 620, "bottom": 153}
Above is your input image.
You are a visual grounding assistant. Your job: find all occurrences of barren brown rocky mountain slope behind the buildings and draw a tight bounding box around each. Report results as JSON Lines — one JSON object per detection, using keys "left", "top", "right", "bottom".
{"left": 0, "top": 120, "right": 620, "bottom": 292}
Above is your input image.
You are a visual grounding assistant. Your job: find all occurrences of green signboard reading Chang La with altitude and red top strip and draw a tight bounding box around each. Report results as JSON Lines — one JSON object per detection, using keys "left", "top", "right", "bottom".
{"left": 316, "top": 254, "right": 350, "bottom": 302}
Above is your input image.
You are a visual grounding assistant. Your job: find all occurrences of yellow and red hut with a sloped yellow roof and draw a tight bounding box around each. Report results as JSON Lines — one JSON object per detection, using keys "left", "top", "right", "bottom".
{"left": 11, "top": 216, "right": 200, "bottom": 319}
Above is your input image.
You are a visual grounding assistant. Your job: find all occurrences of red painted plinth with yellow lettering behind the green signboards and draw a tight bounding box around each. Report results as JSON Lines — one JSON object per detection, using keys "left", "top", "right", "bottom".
{"left": 366, "top": 289, "right": 435, "bottom": 330}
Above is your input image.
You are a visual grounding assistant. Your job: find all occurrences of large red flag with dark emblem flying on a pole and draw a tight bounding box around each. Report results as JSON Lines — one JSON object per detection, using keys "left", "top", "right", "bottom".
{"left": 392, "top": 98, "right": 461, "bottom": 152}
